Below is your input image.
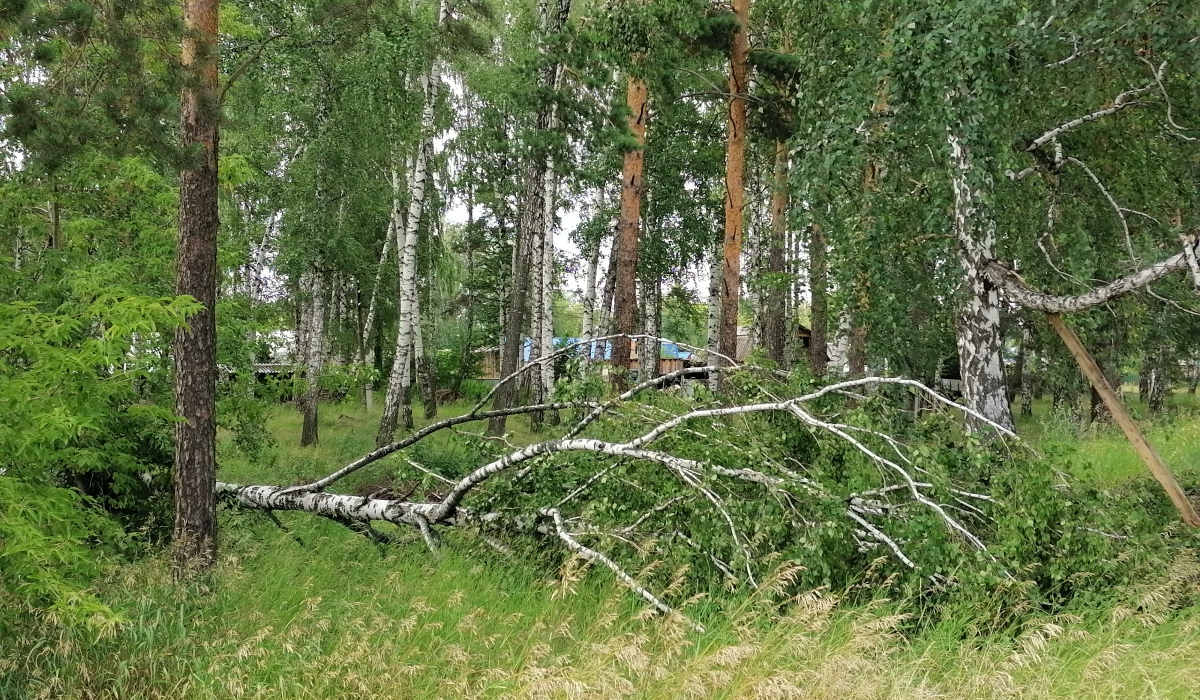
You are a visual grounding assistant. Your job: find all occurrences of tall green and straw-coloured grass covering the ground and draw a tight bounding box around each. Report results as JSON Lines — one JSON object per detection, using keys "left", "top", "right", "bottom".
{"left": 7, "top": 395, "right": 1200, "bottom": 700}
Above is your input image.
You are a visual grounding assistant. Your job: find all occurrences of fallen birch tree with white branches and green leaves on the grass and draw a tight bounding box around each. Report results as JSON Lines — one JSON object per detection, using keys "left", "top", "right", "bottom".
{"left": 217, "top": 339, "right": 1041, "bottom": 612}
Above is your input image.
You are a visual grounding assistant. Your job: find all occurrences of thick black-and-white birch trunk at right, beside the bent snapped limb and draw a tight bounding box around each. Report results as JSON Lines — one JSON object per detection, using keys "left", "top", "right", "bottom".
{"left": 947, "top": 128, "right": 1013, "bottom": 429}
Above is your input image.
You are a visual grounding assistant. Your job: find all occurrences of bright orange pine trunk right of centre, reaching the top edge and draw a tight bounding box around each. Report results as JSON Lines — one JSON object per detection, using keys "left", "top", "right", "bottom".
{"left": 720, "top": 0, "right": 750, "bottom": 367}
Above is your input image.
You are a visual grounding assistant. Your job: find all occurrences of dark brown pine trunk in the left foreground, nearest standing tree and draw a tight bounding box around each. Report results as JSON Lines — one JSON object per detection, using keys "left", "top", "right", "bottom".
{"left": 174, "top": 0, "right": 220, "bottom": 578}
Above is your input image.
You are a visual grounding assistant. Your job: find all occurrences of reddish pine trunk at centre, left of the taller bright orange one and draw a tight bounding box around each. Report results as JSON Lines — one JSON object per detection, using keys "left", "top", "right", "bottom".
{"left": 612, "top": 76, "right": 648, "bottom": 387}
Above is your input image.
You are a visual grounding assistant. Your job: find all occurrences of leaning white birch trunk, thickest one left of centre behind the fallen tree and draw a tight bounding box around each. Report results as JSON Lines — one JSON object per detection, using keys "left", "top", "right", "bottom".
{"left": 376, "top": 68, "right": 445, "bottom": 447}
